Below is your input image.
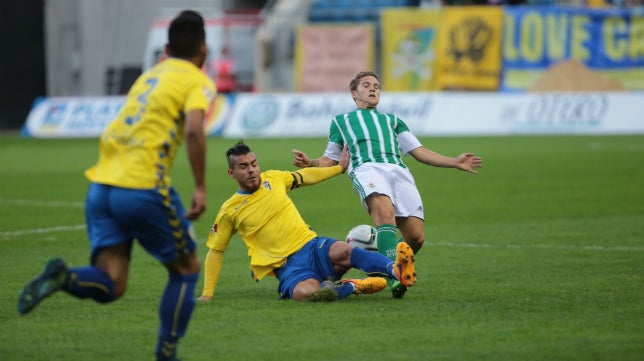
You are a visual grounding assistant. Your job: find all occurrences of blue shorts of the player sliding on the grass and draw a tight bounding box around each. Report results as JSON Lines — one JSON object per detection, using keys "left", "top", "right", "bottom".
{"left": 275, "top": 237, "right": 342, "bottom": 298}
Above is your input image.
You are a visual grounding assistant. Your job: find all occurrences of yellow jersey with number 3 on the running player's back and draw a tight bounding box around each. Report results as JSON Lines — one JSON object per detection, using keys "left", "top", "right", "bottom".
{"left": 85, "top": 58, "right": 215, "bottom": 189}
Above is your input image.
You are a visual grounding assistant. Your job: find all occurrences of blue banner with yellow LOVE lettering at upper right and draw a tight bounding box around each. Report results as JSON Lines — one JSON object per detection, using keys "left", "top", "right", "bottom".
{"left": 501, "top": 6, "right": 644, "bottom": 91}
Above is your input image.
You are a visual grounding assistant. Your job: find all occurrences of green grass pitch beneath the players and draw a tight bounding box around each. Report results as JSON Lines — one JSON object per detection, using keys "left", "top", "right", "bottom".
{"left": 0, "top": 136, "right": 644, "bottom": 361}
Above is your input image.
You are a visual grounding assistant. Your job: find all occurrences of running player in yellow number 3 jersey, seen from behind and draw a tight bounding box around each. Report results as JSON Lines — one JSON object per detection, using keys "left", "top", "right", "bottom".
{"left": 18, "top": 10, "right": 215, "bottom": 360}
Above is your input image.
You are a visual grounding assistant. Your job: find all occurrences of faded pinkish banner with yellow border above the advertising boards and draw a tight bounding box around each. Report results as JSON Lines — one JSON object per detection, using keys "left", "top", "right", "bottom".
{"left": 294, "top": 24, "right": 375, "bottom": 92}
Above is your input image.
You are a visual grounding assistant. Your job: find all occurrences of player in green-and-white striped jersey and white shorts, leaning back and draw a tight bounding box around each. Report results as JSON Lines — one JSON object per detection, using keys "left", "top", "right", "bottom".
{"left": 293, "top": 71, "right": 482, "bottom": 298}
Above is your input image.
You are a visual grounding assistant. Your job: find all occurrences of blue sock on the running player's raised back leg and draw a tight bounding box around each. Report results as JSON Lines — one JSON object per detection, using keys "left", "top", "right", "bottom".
{"left": 65, "top": 266, "right": 114, "bottom": 303}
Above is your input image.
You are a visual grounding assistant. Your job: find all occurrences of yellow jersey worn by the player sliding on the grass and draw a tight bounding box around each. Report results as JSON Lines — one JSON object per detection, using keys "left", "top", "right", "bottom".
{"left": 207, "top": 170, "right": 317, "bottom": 280}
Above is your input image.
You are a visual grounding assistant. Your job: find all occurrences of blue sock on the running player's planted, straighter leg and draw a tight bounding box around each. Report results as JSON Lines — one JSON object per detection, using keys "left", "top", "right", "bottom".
{"left": 156, "top": 273, "right": 199, "bottom": 359}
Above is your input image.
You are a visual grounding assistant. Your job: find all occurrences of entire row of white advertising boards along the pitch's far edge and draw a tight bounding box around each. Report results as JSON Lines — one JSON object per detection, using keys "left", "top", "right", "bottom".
{"left": 23, "top": 92, "right": 644, "bottom": 139}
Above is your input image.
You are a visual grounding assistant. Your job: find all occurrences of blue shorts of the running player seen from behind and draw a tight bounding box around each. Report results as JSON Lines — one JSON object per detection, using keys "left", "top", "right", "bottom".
{"left": 85, "top": 183, "right": 197, "bottom": 263}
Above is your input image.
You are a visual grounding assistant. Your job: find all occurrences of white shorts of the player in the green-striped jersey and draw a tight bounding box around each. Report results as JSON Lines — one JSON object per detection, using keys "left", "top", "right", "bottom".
{"left": 349, "top": 163, "right": 425, "bottom": 220}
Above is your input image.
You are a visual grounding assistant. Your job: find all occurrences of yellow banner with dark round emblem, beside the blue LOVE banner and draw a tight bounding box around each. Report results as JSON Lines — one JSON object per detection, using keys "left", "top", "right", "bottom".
{"left": 436, "top": 6, "right": 503, "bottom": 90}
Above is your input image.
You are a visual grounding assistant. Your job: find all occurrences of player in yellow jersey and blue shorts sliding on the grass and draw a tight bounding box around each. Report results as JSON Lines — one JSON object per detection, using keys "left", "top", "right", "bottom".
{"left": 199, "top": 142, "right": 416, "bottom": 301}
